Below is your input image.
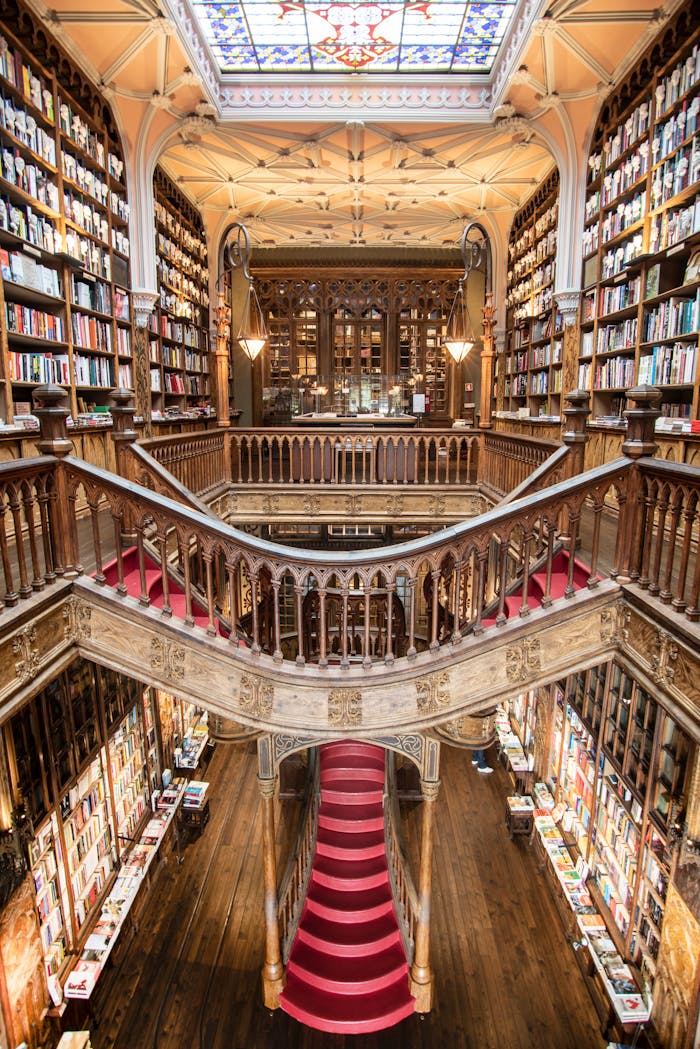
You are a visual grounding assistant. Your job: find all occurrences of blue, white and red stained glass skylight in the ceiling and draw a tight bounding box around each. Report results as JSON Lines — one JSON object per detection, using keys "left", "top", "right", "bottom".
{"left": 190, "top": 0, "right": 517, "bottom": 73}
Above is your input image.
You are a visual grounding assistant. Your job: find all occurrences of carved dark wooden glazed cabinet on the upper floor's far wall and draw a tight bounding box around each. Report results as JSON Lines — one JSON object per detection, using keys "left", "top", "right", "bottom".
{"left": 254, "top": 263, "right": 459, "bottom": 423}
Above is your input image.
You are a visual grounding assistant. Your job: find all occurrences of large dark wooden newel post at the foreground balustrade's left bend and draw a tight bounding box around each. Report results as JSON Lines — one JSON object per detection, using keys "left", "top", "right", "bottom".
{"left": 34, "top": 383, "right": 82, "bottom": 579}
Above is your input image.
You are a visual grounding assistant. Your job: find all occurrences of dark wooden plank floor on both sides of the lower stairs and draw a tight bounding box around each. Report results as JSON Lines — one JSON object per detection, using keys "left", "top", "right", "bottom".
{"left": 89, "top": 745, "right": 607, "bottom": 1049}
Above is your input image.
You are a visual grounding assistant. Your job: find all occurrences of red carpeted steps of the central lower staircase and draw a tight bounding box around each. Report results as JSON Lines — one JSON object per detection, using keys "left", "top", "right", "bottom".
{"left": 280, "top": 741, "right": 415, "bottom": 1034}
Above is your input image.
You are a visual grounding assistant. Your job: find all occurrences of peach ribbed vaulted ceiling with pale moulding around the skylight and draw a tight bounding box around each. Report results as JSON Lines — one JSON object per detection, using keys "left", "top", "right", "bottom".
{"left": 31, "top": 0, "right": 679, "bottom": 253}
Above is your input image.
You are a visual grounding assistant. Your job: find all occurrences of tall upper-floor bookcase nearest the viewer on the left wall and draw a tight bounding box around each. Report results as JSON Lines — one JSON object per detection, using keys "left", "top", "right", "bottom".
{"left": 0, "top": 3, "right": 133, "bottom": 424}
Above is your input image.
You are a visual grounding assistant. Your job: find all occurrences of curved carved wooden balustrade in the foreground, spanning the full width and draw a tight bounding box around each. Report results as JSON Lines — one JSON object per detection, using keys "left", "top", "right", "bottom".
{"left": 0, "top": 391, "right": 700, "bottom": 654}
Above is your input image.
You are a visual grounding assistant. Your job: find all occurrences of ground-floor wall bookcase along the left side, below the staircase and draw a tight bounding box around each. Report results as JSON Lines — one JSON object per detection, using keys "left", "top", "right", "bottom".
{"left": 9, "top": 660, "right": 158, "bottom": 978}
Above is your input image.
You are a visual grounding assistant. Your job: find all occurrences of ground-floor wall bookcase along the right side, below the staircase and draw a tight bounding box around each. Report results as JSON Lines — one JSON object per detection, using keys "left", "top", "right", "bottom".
{"left": 528, "top": 662, "right": 690, "bottom": 982}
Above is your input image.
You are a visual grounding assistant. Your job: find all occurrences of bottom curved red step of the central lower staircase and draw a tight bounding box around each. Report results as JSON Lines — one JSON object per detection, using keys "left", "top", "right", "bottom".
{"left": 280, "top": 973, "right": 415, "bottom": 1034}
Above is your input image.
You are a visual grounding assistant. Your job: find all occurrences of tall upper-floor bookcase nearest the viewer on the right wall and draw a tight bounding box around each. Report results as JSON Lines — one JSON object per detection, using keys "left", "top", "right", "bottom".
{"left": 578, "top": 16, "right": 700, "bottom": 432}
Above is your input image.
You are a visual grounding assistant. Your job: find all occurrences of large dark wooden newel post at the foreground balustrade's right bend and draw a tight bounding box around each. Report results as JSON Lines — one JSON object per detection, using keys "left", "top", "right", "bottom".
{"left": 615, "top": 386, "right": 662, "bottom": 583}
